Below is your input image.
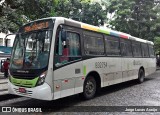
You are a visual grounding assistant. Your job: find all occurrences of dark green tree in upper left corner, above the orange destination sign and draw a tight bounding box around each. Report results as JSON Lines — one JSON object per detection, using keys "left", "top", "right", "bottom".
{"left": 0, "top": 0, "right": 57, "bottom": 33}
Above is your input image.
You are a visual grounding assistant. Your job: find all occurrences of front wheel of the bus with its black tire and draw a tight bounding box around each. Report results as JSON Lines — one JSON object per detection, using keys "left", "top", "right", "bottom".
{"left": 81, "top": 76, "right": 97, "bottom": 100}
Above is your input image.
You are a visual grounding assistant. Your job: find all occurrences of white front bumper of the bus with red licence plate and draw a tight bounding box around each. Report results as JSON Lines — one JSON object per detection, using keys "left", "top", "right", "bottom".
{"left": 8, "top": 81, "right": 53, "bottom": 100}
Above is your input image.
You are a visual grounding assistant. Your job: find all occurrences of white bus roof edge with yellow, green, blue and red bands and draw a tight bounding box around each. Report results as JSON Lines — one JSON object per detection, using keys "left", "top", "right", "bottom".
{"left": 28, "top": 17, "right": 153, "bottom": 45}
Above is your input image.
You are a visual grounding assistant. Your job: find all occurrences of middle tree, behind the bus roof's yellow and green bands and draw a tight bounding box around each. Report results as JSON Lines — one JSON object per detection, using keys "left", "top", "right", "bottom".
{"left": 55, "top": 0, "right": 107, "bottom": 26}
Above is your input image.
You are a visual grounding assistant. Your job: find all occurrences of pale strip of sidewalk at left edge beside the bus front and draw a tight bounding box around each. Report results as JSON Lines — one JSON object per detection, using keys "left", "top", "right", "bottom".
{"left": 0, "top": 72, "right": 8, "bottom": 95}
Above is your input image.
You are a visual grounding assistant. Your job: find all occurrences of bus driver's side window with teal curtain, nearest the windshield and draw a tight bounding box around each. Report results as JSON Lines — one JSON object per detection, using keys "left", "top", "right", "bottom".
{"left": 55, "top": 27, "right": 81, "bottom": 67}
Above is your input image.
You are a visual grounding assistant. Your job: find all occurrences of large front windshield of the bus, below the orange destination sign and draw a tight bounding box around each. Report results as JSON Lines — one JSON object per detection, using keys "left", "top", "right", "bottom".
{"left": 10, "top": 29, "right": 52, "bottom": 69}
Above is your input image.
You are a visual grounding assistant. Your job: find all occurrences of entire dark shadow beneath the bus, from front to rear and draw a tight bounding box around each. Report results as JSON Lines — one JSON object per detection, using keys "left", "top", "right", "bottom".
{"left": 9, "top": 78, "right": 154, "bottom": 112}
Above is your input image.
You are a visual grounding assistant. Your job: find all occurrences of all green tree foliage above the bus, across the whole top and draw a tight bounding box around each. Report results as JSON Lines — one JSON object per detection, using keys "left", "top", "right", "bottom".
{"left": 0, "top": 0, "right": 160, "bottom": 54}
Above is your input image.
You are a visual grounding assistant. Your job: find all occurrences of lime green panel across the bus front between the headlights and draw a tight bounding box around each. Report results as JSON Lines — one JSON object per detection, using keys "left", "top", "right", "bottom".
{"left": 10, "top": 77, "right": 39, "bottom": 87}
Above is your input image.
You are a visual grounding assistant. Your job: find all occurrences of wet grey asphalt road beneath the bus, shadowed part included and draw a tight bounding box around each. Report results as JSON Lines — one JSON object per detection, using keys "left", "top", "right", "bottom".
{"left": 0, "top": 70, "right": 160, "bottom": 115}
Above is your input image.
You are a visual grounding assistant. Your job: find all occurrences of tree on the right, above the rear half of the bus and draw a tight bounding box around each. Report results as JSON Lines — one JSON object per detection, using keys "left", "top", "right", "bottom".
{"left": 109, "top": 0, "right": 157, "bottom": 41}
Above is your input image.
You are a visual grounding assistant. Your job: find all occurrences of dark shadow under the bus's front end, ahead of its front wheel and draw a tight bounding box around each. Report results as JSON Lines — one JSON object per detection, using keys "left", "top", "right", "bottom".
{"left": 11, "top": 95, "right": 82, "bottom": 112}
